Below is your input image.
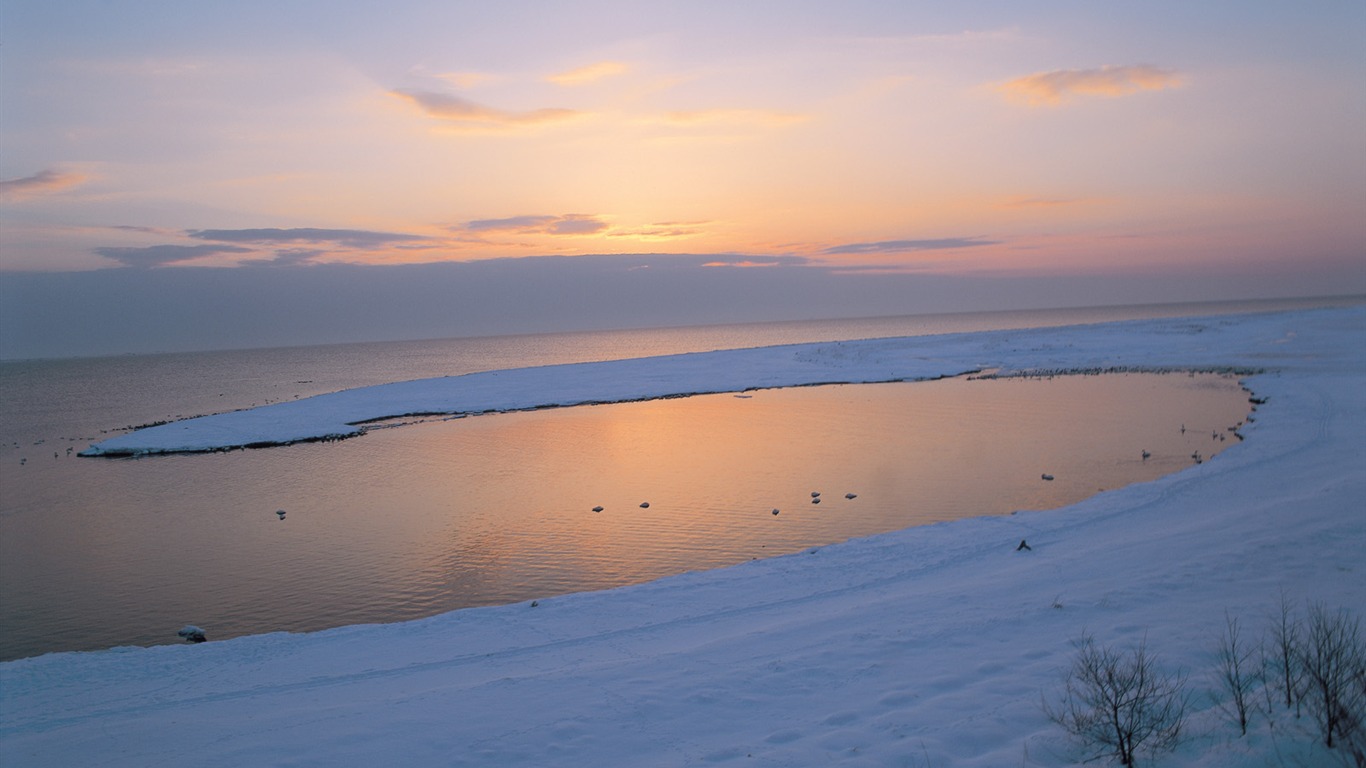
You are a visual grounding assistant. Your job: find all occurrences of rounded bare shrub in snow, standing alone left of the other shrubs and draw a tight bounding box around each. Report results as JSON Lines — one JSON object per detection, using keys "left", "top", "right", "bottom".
{"left": 1044, "top": 635, "right": 1187, "bottom": 767}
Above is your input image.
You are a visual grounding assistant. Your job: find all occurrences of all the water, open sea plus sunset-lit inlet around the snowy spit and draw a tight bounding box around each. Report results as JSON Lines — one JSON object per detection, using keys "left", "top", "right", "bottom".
{"left": 0, "top": 292, "right": 1361, "bottom": 660}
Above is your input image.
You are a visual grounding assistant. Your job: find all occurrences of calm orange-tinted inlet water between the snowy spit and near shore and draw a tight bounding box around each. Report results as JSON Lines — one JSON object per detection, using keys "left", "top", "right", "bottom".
{"left": 0, "top": 374, "right": 1249, "bottom": 657}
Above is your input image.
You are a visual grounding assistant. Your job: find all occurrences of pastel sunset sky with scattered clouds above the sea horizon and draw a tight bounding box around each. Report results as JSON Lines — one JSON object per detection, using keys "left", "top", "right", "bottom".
{"left": 0, "top": 0, "right": 1366, "bottom": 358}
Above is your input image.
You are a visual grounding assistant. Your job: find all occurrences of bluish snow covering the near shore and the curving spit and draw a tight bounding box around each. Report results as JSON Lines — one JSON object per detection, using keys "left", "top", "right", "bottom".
{"left": 0, "top": 306, "right": 1366, "bottom": 767}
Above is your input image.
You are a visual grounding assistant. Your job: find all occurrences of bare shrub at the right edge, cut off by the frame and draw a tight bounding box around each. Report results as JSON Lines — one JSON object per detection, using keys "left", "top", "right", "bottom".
{"left": 1296, "top": 603, "right": 1366, "bottom": 764}
